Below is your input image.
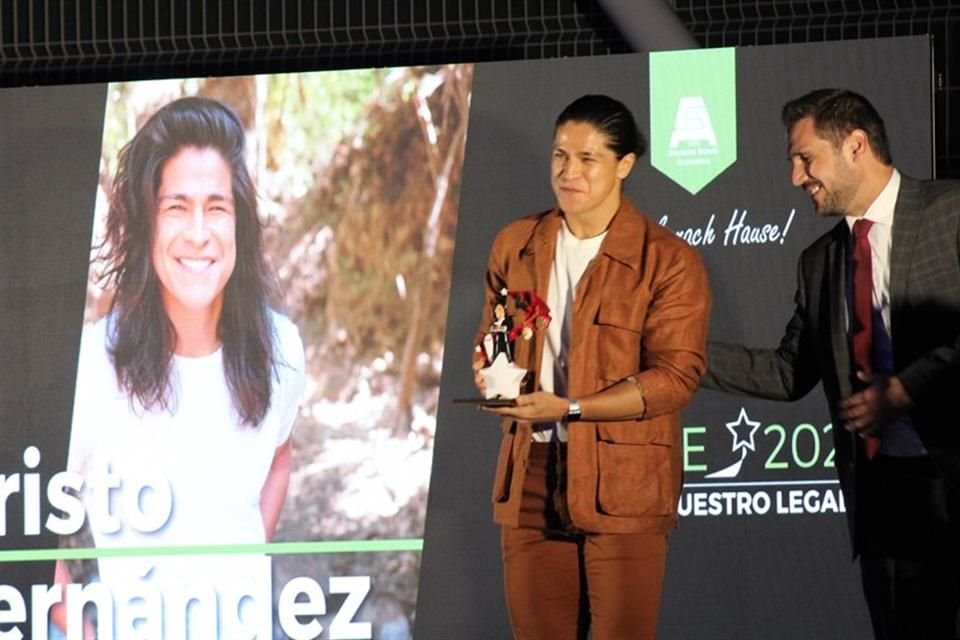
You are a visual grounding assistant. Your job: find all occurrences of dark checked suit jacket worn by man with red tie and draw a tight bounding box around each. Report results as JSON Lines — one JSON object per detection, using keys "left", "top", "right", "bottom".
{"left": 701, "top": 176, "right": 960, "bottom": 553}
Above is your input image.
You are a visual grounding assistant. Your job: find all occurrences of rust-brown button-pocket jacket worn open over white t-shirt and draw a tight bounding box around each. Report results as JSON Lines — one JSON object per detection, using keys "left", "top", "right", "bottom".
{"left": 476, "top": 198, "right": 710, "bottom": 533}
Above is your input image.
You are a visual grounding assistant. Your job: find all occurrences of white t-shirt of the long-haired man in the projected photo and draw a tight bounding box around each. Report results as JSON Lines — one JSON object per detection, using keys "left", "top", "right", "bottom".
{"left": 67, "top": 312, "right": 305, "bottom": 638}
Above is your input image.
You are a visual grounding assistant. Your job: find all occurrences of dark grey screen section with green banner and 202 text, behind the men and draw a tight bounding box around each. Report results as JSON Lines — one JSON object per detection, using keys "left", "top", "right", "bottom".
{"left": 416, "top": 37, "right": 932, "bottom": 640}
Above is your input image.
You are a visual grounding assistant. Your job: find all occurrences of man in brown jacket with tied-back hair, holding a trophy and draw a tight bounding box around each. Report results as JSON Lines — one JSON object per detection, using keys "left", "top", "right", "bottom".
{"left": 474, "top": 96, "right": 710, "bottom": 640}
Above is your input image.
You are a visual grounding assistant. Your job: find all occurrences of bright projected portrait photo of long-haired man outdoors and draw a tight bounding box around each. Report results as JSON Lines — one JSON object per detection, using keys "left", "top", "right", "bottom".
{"left": 51, "top": 66, "right": 472, "bottom": 638}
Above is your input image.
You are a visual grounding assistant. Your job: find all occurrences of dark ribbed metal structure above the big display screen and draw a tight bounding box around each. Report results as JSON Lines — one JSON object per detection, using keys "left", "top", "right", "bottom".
{"left": 0, "top": 0, "right": 960, "bottom": 177}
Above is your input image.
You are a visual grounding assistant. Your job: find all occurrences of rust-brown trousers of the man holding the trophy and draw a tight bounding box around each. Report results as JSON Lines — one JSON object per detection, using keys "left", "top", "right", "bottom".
{"left": 501, "top": 443, "right": 667, "bottom": 640}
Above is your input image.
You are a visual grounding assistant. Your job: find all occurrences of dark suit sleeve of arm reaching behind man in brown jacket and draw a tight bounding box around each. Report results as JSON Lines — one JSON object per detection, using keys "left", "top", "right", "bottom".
{"left": 701, "top": 254, "right": 820, "bottom": 400}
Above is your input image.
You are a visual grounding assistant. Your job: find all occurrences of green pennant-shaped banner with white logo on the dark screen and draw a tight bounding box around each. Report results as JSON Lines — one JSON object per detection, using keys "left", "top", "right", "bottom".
{"left": 650, "top": 47, "right": 737, "bottom": 193}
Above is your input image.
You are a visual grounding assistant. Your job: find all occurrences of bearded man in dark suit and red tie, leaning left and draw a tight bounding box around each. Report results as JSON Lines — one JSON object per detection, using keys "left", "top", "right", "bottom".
{"left": 702, "top": 89, "right": 960, "bottom": 639}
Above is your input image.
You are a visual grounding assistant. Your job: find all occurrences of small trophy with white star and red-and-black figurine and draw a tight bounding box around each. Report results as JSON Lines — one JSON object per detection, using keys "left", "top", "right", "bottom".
{"left": 478, "top": 289, "right": 550, "bottom": 400}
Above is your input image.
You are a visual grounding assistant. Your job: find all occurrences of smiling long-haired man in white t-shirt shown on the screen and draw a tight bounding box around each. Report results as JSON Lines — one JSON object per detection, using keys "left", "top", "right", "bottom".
{"left": 55, "top": 98, "right": 304, "bottom": 637}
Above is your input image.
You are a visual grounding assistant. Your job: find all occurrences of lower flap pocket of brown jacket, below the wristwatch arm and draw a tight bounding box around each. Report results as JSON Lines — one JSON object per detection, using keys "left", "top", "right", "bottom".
{"left": 597, "top": 439, "right": 675, "bottom": 517}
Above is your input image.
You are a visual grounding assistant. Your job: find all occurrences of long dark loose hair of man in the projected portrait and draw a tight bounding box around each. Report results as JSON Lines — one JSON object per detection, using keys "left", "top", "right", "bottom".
{"left": 103, "top": 98, "right": 277, "bottom": 426}
